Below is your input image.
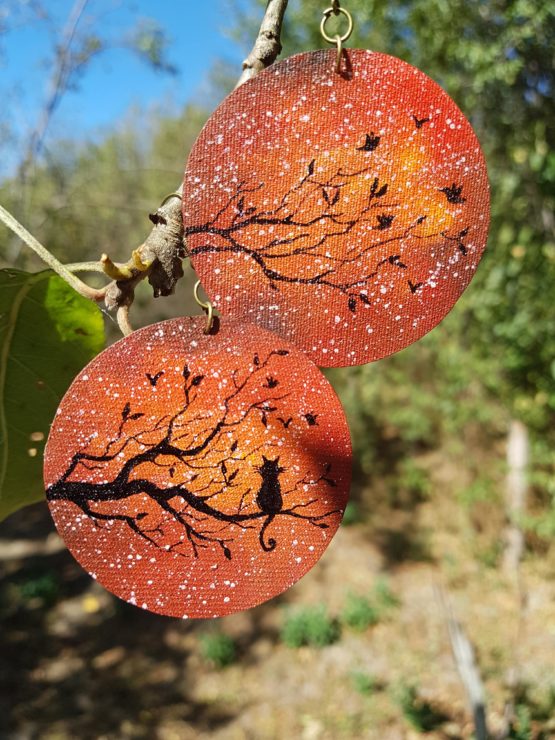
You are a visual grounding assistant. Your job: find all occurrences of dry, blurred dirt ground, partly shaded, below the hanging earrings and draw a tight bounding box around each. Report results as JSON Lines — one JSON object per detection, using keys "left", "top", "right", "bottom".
{"left": 0, "top": 468, "right": 555, "bottom": 740}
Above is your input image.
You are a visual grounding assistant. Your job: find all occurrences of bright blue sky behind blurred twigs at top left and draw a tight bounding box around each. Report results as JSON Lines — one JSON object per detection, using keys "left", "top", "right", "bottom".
{"left": 0, "top": 0, "right": 254, "bottom": 173}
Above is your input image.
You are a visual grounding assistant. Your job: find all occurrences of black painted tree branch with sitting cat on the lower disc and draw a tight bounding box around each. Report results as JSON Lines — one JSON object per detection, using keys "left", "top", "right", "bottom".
{"left": 46, "top": 349, "right": 340, "bottom": 559}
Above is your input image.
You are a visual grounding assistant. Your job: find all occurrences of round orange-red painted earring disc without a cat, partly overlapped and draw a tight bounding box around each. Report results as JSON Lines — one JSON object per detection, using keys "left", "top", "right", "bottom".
{"left": 183, "top": 50, "right": 489, "bottom": 366}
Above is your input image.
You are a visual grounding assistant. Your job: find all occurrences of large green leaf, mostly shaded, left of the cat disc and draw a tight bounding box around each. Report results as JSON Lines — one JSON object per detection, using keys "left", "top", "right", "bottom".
{"left": 0, "top": 269, "right": 104, "bottom": 520}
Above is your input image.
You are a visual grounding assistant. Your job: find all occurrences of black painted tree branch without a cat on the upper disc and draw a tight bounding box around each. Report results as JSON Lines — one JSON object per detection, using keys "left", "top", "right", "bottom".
{"left": 185, "top": 139, "right": 468, "bottom": 312}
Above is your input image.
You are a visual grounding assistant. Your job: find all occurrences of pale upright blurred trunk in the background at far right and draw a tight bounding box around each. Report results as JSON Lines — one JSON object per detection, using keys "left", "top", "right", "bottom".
{"left": 503, "top": 419, "right": 529, "bottom": 575}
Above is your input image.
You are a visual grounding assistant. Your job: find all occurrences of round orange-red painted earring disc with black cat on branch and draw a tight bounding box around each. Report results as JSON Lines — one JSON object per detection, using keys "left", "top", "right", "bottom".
{"left": 44, "top": 317, "right": 351, "bottom": 618}
